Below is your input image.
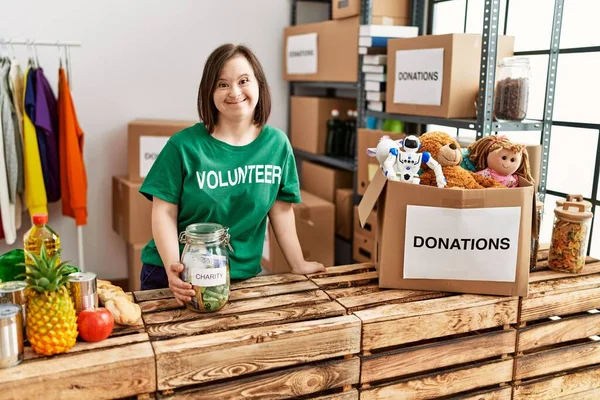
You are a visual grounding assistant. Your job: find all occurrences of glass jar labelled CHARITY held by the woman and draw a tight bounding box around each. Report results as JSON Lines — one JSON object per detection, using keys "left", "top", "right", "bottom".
{"left": 179, "top": 223, "right": 232, "bottom": 312}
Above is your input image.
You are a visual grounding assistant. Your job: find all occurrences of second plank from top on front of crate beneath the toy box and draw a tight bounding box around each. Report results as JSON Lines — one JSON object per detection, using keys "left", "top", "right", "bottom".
{"left": 360, "top": 329, "right": 516, "bottom": 383}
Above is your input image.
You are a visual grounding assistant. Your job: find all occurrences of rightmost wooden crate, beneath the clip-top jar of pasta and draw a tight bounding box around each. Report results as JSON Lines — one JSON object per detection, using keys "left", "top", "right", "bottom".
{"left": 514, "top": 251, "right": 600, "bottom": 399}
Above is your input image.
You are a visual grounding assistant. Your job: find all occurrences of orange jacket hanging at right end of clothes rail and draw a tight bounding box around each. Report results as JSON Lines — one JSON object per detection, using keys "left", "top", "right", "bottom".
{"left": 58, "top": 68, "right": 87, "bottom": 225}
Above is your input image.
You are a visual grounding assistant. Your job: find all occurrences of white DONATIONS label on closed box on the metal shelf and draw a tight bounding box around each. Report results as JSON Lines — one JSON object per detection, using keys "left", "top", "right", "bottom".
{"left": 394, "top": 49, "right": 444, "bottom": 106}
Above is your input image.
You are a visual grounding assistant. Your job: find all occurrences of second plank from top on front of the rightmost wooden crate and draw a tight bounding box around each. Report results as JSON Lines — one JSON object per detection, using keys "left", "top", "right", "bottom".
{"left": 517, "top": 313, "right": 600, "bottom": 352}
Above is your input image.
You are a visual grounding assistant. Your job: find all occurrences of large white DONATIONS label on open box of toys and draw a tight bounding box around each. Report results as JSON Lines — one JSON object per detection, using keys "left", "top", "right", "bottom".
{"left": 404, "top": 205, "right": 521, "bottom": 282}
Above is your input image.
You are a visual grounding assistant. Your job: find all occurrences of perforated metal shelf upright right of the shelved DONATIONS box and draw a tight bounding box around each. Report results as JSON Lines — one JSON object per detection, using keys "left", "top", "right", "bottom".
{"left": 476, "top": 0, "right": 500, "bottom": 139}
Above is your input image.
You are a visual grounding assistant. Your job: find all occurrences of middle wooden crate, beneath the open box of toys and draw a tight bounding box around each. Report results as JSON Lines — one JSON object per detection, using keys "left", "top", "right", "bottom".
{"left": 310, "top": 263, "right": 518, "bottom": 400}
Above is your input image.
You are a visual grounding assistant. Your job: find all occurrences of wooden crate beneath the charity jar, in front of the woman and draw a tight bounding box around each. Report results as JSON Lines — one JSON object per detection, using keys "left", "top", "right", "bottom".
{"left": 135, "top": 274, "right": 361, "bottom": 400}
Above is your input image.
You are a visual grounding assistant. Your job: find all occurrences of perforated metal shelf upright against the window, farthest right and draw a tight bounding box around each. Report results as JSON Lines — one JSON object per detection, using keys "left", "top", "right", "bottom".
{"left": 538, "top": 0, "right": 564, "bottom": 201}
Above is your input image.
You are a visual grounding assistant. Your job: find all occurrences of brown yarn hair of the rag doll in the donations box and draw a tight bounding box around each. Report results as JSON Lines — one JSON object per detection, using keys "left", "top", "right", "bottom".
{"left": 468, "top": 135, "right": 535, "bottom": 184}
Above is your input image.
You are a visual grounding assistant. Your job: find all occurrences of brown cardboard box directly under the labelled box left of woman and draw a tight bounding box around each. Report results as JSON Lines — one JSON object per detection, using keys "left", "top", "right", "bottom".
{"left": 112, "top": 176, "right": 152, "bottom": 243}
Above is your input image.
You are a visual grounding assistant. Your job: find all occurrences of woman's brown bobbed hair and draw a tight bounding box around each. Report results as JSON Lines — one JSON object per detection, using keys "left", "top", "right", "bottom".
{"left": 198, "top": 43, "right": 271, "bottom": 133}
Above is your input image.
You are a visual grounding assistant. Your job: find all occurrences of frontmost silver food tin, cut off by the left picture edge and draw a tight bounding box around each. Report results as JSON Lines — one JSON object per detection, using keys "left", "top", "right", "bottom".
{"left": 0, "top": 304, "right": 23, "bottom": 368}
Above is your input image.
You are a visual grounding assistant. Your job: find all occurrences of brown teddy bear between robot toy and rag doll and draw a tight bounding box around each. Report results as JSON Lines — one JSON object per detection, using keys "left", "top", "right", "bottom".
{"left": 419, "top": 132, "right": 504, "bottom": 189}
